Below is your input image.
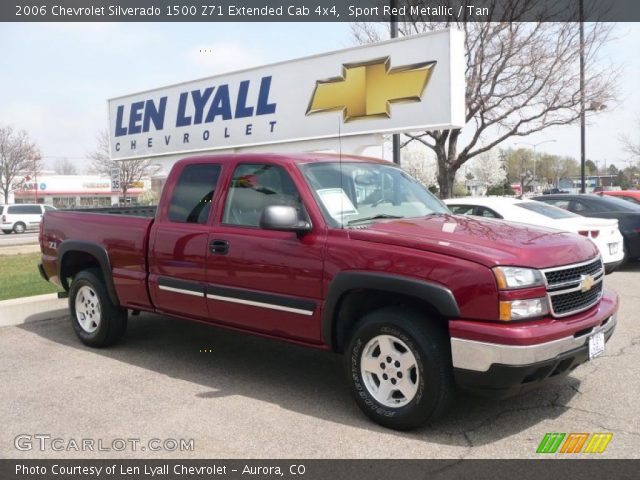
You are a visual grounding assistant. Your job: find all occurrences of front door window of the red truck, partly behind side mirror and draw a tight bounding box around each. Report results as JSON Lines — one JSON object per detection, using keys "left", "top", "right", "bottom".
{"left": 222, "top": 164, "right": 302, "bottom": 227}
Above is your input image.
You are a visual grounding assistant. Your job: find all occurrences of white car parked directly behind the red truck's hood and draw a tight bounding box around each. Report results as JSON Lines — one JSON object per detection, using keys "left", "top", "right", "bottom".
{"left": 444, "top": 197, "right": 624, "bottom": 273}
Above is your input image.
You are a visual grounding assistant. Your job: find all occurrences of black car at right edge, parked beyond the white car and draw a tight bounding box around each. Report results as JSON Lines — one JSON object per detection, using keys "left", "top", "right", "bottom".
{"left": 533, "top": 194, "right": 640, "bottom": 261}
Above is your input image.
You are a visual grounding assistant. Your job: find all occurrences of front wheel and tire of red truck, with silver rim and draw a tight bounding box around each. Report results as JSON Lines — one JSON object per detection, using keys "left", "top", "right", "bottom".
{"left": 344, "top": 307, "right": 454, "bottom": 430}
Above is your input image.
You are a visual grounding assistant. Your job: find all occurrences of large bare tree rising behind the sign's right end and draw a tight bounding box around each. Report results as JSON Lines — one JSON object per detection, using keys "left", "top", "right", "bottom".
{"left": 352, "top": 0, "right": 618, "bottom": 198}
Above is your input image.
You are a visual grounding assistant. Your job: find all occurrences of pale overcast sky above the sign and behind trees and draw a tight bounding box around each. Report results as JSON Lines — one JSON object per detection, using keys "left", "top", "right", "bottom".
{"left": 0, "top": 23, "right": 640, "bottom": 172}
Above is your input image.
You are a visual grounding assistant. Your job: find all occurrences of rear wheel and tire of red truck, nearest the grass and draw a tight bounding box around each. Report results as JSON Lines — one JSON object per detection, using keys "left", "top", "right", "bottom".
{"left": 69, "top": 268, "right": 128, "bottom": 348}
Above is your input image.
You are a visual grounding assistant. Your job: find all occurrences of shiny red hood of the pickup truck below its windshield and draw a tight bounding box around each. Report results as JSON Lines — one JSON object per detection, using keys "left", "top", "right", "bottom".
{"left": 349, "top": 214, "right": 598, "bottom": 268}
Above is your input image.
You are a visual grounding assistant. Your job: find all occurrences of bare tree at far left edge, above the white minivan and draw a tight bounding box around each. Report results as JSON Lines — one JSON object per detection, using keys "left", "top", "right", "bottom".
{"left": 0, "top": 126, "right": 42, "bottom": 203}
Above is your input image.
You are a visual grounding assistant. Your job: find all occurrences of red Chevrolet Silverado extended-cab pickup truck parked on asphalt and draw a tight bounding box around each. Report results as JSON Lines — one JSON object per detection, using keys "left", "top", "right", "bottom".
{"left": 39, "top": 154, "right": 618, "bottom": 429}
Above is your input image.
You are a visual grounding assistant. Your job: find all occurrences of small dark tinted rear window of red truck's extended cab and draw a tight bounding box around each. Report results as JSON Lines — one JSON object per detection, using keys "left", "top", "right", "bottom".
{"left": 169, "top": 163, "right": 220, "bottom": 224}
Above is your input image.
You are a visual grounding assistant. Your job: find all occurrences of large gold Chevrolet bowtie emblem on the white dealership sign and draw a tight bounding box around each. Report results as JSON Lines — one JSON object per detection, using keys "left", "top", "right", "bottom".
{"left": 307, "top": 57, "right": 436, "bottom": 122}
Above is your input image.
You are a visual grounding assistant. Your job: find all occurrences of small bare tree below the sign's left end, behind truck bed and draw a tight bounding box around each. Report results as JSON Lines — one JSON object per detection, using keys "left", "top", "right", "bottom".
{"left": 88, "top": 130, "right": 159, "bottom": 202}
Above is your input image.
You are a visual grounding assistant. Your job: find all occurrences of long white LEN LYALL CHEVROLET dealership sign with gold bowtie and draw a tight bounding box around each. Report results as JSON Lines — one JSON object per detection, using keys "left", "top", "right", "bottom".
{"left": 109, "top": 29, "right": 465, "bottom": 159}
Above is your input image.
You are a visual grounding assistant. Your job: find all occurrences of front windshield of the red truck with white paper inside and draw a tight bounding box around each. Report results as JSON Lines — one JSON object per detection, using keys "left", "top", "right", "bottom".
{"left": 300, "top": 162, "right": 449, "bottom": 227}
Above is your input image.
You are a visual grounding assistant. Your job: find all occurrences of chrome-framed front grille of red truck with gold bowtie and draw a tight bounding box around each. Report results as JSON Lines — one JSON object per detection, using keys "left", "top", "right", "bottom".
{"left": 542, "top": 257, "right": 604, "bottom": 317}
